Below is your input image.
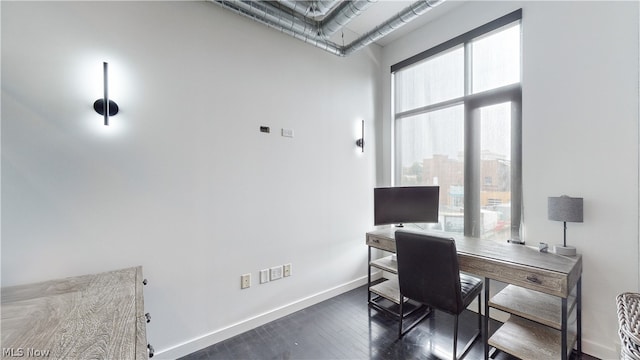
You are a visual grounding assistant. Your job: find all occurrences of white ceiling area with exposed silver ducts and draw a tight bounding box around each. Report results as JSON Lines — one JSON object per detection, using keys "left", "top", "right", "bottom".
{"left": 212, "top": 0, "right": 462, "bottom": 56}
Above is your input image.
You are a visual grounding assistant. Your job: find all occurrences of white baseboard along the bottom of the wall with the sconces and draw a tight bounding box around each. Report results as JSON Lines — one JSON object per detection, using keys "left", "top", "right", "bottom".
{"left": 154, "top": 276, "right": 367, "bottom": 359}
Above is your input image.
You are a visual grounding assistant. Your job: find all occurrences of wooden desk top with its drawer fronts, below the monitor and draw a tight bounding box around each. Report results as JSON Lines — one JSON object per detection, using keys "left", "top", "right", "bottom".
{"left": 367, "top": 227, "right": 582, "bottom": 297}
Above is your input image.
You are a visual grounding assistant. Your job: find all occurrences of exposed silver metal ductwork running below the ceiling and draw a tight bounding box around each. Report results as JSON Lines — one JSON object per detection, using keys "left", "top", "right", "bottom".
{"left": 214, "top": 0, "right": 444, "bottom": 56}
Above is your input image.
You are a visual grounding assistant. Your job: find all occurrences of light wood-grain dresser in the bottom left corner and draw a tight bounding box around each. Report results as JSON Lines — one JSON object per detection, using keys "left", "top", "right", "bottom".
{"left": 0, "top": 266, "right": 153, "bottom": 360}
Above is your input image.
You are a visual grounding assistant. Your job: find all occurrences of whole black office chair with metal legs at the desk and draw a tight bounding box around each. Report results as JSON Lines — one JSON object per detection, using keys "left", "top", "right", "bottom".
{"left": 395, "top": 231, "right": 482, "bottom": 359}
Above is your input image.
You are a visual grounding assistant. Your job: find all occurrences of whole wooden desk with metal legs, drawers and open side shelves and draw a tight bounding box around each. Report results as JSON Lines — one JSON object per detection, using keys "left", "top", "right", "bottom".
{"left": 366, "top": 227, "right": 582, "bottom": 360}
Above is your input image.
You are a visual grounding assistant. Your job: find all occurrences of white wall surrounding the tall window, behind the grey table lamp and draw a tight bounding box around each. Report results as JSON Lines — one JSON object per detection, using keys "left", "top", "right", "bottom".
{"left": 377, "top": 1, "right": 640, "bottom": 359}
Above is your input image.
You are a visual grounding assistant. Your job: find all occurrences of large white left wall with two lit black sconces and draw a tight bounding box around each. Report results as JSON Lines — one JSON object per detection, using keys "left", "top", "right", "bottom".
{"left": 1, "top": 1, "right": 380, "bottom": 358}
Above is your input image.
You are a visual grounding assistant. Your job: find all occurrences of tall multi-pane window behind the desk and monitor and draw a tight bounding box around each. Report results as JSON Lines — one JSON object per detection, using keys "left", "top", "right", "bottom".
{"left": 391, "top": 10, "right": 522, "bottom": 241}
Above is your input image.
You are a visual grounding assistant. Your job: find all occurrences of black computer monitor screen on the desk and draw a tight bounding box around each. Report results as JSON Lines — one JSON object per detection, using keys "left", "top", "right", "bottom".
{"left": 373, "top": 186, "right": 440, "bottom": 225}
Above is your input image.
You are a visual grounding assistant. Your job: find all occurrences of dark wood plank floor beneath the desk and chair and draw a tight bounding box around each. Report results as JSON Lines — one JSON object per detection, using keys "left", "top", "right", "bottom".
{"left": 182, "top": 286, "right": 595, "bottom": 360}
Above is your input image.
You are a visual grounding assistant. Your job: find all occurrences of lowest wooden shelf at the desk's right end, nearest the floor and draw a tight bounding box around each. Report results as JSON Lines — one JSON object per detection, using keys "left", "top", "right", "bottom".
{"left": 489, "top": 315, "right": 577, "bottom": 360}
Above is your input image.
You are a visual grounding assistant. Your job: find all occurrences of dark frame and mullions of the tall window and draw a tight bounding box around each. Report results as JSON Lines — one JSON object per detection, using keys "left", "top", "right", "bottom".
{"left": 391, "top": 9, "right": 523, "bottom": 239}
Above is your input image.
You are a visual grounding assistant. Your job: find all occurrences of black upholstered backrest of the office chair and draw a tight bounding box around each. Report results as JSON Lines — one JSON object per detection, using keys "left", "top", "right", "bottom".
{"left": 395, "top": 230, "right": 463, "bottom": 314}
